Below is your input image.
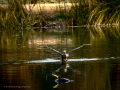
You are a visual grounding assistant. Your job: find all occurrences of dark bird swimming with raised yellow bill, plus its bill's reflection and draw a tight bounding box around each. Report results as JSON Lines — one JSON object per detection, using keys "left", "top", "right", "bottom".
{"left": 52, "top": 74, "right": 74, "bottom": 88}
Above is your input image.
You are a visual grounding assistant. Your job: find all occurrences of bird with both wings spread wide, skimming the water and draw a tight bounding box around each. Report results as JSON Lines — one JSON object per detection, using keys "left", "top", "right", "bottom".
{"left": 46, "top": 44, "right": 91, "bottom": 63}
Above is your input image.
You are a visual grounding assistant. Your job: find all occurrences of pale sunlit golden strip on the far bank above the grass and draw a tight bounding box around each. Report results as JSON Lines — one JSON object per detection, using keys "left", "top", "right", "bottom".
{"left": 24, "top": 3, "right": 72, "bottom": 13}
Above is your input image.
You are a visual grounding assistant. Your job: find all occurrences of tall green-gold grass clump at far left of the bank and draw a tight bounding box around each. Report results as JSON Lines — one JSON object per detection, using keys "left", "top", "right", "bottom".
{"left": 0, "top": 0, "right": 36, "bottom": 29}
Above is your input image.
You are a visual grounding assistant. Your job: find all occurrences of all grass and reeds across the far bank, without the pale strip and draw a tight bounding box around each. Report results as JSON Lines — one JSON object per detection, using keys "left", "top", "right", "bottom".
{"left": 0, "top": 0, "right": 120, "bottom": 29}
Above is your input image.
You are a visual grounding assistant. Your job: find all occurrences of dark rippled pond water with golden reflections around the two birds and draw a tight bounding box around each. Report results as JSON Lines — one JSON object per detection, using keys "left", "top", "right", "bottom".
{"left": 0, "top": 27, "right": 120, "bottom": 90}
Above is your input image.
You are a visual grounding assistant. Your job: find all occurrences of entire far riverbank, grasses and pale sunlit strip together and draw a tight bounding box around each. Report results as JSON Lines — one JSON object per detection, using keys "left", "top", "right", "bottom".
{"left": 0, "top": 0, "right": 120, "bottom": 29}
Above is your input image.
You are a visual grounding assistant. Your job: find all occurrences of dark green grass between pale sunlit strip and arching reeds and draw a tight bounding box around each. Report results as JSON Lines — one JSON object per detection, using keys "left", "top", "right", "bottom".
{"left": 57, "top": 0, "right": 89, "bottom": 26}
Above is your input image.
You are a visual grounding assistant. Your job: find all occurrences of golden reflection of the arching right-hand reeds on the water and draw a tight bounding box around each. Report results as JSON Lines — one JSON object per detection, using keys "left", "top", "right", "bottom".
{"left": 89, "top": 27, "right": 120, "bottom": 39}
